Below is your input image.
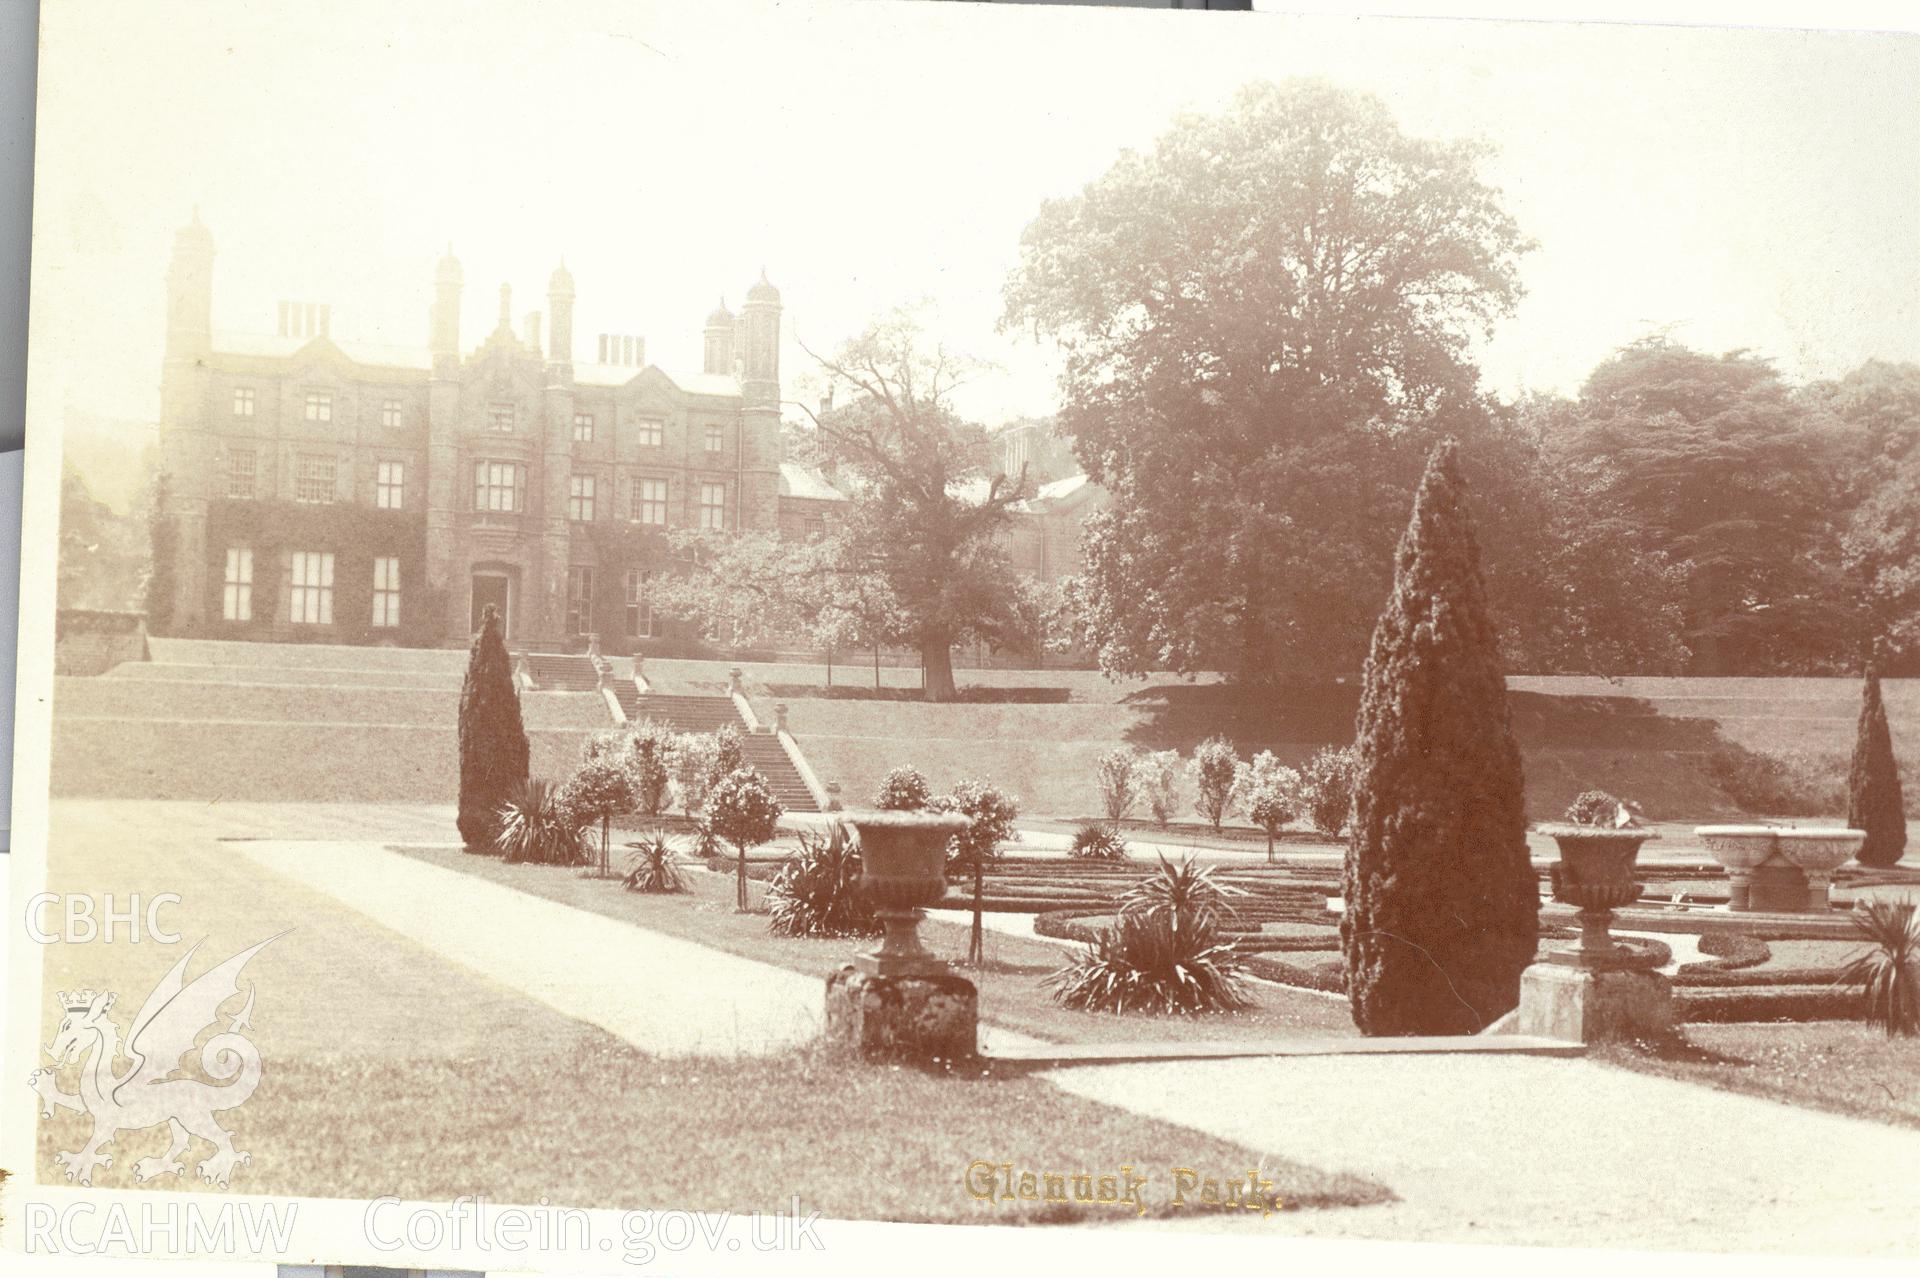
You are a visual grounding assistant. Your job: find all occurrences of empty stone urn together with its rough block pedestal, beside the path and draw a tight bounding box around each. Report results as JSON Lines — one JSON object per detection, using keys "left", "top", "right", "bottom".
{"left": 826, "top": 812, "right": 979, "bottom": 1061}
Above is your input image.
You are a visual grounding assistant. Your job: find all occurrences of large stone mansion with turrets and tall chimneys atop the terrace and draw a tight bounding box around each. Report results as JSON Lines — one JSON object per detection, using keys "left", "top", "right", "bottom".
{"left": 150, "top": 215, "right": 1091, "bottom": 652}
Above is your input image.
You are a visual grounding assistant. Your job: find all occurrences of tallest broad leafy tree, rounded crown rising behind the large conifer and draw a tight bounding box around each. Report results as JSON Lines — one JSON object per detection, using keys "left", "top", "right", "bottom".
{"left": 1006, "top": 81, "right": 1526, "bottom": 677}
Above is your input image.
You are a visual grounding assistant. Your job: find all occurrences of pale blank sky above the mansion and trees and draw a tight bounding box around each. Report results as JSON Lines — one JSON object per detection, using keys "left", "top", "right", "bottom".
{"left": 27, "top": 0, "right": 1920, "bottom": 460}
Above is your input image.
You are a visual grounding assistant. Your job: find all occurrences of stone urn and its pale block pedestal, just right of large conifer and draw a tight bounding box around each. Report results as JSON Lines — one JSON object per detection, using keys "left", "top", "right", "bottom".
{"left": 1505, "top": 825, "right": 1674, "bottom": 1042}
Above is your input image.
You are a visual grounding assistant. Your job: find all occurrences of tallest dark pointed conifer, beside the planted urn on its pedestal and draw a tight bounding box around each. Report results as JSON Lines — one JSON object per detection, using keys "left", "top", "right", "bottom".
{"left": 1340, "top": 441, "right": 1540, "bottom": 1034}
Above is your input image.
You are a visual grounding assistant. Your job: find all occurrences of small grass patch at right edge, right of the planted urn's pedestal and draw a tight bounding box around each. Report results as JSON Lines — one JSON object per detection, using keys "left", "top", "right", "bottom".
{"left": 1594, "top": 1021, "right": 1920, "bottom": 1126}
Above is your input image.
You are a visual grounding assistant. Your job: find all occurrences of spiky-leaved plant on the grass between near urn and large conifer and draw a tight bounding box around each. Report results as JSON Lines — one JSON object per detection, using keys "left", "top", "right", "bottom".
{"left": 1046, "top": 911, "right": 1248, "bottom": 1015}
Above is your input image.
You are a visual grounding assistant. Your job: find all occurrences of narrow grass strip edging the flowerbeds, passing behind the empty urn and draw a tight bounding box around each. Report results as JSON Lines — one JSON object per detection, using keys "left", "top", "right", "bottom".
{"left": 394, "top": 846, "right": 1356, "bottom": 1042}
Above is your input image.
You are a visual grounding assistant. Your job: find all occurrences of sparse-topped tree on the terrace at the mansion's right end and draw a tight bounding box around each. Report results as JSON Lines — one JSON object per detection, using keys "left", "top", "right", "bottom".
{"left": 812, "top": 311, "right": 1035, "bottom": 700}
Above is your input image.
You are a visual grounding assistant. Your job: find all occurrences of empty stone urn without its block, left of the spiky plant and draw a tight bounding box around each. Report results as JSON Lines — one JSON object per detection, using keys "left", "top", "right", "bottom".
{"left": 839, "top": 812, "right": 968, "bottom": 977}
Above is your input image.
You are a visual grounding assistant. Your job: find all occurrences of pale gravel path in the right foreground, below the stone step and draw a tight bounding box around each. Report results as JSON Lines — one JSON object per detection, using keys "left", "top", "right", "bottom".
{"left": 1046, "top": 1055, "right": 1920, "bottom": 1255}
